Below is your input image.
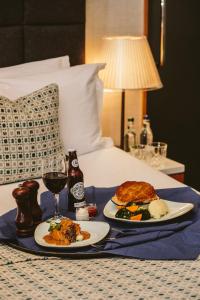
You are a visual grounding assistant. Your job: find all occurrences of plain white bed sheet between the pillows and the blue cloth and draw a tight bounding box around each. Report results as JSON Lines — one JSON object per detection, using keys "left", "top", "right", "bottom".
{"left": 0, "top": 147, "right": 184, "bottom": 215}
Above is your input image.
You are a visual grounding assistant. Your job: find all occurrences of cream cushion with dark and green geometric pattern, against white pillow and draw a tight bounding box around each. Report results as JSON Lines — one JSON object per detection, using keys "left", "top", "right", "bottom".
{"left": 0, "top": 84, "right": 63, "bottom": 184}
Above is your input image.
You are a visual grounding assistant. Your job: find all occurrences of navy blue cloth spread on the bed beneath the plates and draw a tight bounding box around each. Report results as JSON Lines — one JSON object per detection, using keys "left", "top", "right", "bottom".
{"left": 0, "top": 187, "right": 200, "bottom": 259}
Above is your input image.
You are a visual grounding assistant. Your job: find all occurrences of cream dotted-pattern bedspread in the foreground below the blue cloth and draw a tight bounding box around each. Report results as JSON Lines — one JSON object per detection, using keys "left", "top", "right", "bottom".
{"left": 0, "top": 244, "right": 200, "bottom": 300}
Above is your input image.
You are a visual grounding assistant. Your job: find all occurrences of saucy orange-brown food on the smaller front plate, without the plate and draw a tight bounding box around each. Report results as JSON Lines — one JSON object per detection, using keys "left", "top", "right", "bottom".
{"left": 43, "top": 218, "right": 90, "bottom": 245}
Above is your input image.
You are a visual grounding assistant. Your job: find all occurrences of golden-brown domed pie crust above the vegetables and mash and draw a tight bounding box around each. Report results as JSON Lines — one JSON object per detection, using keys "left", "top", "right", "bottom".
{"left": 112, "top": 181, "right": 158, "bottom": 206}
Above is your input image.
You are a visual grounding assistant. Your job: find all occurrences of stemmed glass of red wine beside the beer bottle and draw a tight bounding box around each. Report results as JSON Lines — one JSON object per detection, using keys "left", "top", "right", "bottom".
{"left": 42, "top": 156, "right": 67, "bottom": 219}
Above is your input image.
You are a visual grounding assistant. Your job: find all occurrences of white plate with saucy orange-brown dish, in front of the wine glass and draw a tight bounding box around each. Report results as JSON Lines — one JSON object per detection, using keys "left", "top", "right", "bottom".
{"left": 34, "top": 218, "right": 110, "bottom": 249}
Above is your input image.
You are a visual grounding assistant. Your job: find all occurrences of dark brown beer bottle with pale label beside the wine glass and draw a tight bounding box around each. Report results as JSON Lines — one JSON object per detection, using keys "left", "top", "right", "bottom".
{"left": 67, "top": 149, "right": 86, "bottom": 211}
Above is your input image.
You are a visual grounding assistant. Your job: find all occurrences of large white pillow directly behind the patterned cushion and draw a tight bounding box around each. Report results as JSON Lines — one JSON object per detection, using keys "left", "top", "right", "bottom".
{"left": 0, "top": 64, "right": 113, "bottom": 154}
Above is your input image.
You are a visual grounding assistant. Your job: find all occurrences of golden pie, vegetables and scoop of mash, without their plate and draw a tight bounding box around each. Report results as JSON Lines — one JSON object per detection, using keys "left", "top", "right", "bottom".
{"left": 112, "top": 181, "right": 168, "bottom": 221}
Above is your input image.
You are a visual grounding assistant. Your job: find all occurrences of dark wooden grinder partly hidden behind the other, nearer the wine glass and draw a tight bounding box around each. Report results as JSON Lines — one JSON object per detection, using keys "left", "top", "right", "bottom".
{"left": 22, "top": 180, "right": 42, "bottom": 226}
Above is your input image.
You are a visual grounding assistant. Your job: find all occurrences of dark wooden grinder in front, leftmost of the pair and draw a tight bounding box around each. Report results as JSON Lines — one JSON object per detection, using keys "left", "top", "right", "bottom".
{"left": 12, "top": 185, "right": 34, "bottom": 237}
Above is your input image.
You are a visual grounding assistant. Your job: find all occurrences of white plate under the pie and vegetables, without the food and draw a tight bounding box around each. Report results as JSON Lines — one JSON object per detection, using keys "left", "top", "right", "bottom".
{"left": 103, "top": 199, "right": 194, "bottom": 223}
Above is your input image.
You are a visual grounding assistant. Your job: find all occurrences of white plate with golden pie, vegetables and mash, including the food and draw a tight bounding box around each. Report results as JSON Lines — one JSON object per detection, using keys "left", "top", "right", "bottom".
{"left": 103, "top": 181, "right": 194, "bottom": 223}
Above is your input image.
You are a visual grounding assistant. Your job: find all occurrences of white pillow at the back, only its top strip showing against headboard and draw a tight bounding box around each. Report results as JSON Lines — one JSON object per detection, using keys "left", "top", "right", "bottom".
{"left": 0, "top": 55, "right": 70, "bottom": 78}
